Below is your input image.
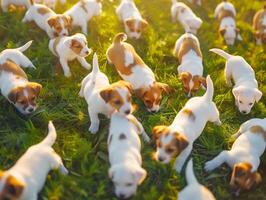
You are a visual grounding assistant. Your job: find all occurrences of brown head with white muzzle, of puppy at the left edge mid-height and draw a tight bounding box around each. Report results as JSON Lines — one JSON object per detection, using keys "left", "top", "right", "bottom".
{"left": 8, "top": 82, "right": 42, "bottom": 115}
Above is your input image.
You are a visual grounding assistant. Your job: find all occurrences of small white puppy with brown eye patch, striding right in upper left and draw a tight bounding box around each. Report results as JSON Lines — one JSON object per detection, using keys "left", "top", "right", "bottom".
{"left": 49, "top": 33, "right": 92, "bottom": 77}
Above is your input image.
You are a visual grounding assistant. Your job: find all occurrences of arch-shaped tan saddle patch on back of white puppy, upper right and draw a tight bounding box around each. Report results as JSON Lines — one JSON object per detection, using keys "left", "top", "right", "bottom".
{"left": 177, "top": 37, "right": 202, "bottom": 64}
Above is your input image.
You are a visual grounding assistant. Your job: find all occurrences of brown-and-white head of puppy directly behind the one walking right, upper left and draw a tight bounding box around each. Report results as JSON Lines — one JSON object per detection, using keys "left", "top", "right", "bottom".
{"left": 47, "top": 15, "right": 72, "bottom": 36}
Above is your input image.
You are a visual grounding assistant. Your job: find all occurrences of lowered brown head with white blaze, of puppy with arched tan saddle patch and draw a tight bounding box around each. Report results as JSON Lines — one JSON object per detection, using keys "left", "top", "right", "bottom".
{"left": 180, "top": 72, "right": 207, "bottom": 97}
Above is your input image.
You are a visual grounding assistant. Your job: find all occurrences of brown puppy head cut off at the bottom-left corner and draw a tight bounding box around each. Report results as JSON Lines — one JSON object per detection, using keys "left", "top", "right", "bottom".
{"left": 0, "top": 172, "right": 25, "bottom": 200}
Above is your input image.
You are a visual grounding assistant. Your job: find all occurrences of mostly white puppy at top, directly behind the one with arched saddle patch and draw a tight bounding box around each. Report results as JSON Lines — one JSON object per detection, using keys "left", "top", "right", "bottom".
{"left": 171, "top": 0, "right": 202, "bottom": 35}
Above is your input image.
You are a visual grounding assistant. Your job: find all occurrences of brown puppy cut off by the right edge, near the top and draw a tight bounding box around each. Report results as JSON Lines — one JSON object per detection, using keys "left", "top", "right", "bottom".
{"left": 253, "top": 5, "right": 266, "bottom": 45}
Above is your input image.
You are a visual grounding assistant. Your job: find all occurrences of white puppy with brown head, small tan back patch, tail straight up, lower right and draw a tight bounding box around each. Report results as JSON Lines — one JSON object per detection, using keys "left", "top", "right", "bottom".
{"left": 153, "top": 76, "right": 221, "bottom": 172}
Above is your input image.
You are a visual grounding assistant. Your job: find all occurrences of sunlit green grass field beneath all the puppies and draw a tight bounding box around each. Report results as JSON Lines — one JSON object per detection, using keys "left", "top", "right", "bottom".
{"left": 0, "top": 0, "right": 266, "bottom": 200}
